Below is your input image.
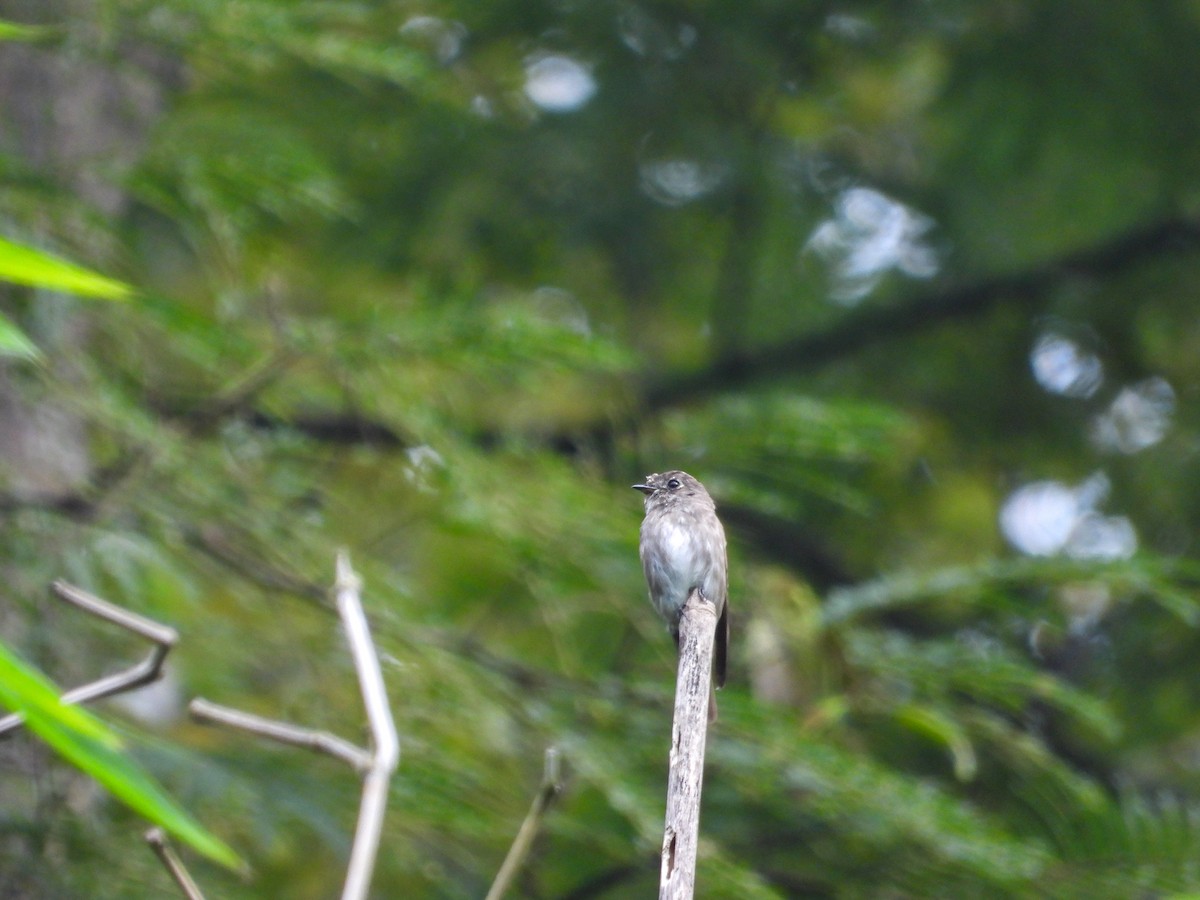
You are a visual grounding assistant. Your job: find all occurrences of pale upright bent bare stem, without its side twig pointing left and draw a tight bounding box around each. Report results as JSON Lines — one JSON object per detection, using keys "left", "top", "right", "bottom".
{"left": 335, "top": 551, "right": 400, "bottom": 900}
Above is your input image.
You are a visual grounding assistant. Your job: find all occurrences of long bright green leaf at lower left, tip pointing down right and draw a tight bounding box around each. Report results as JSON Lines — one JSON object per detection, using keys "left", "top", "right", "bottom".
{"left": 0, "top": 643, "right": 242, "bottom": 869}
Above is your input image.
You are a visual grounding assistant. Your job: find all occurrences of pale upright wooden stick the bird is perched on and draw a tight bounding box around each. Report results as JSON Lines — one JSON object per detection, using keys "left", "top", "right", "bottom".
{"left": 659, "top": 590, "right": 716, "bottom": 900}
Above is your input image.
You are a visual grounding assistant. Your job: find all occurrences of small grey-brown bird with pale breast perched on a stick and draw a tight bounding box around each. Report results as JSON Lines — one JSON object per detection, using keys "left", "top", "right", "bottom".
{"left": 634, "top": 470, "right": 730, "bottom": 720}
